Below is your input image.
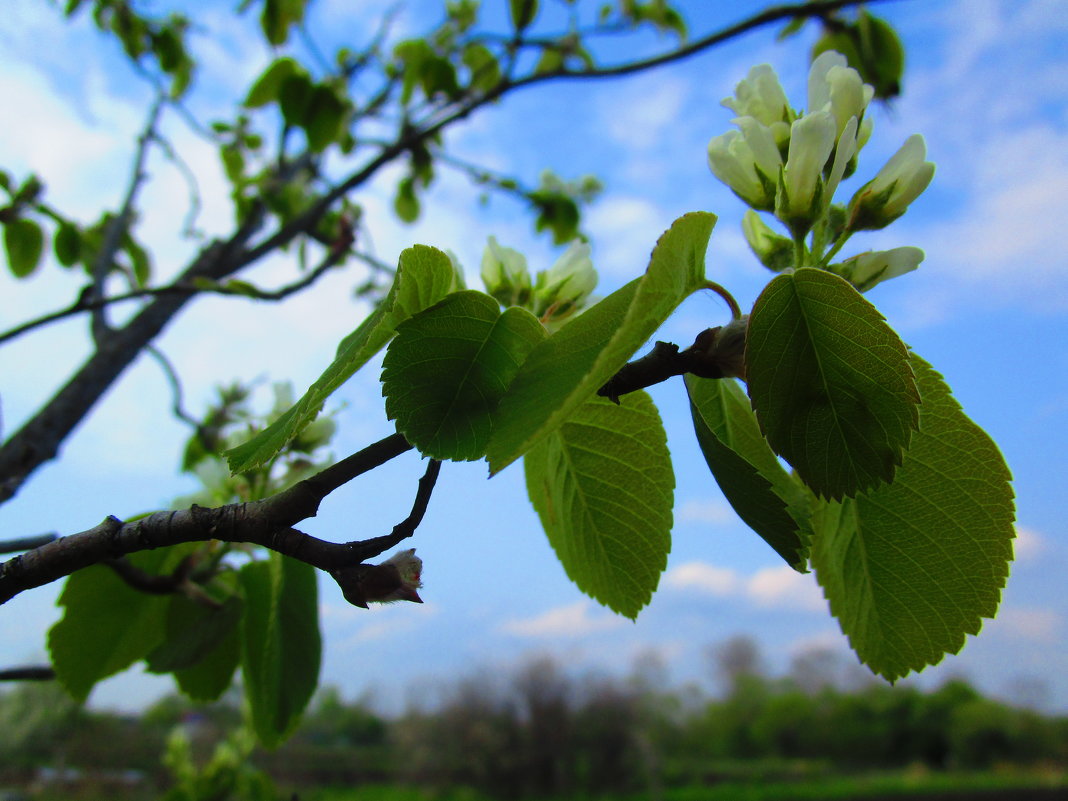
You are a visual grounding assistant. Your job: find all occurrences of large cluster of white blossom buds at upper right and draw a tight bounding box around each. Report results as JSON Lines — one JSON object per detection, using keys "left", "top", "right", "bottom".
{"left": 708, "top": 51, "right": 935, "bottom": 290}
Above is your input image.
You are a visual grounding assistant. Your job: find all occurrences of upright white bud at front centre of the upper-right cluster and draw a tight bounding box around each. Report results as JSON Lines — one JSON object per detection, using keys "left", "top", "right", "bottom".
{"left": 775, "top": 111, "right": 836, "bottom": 235}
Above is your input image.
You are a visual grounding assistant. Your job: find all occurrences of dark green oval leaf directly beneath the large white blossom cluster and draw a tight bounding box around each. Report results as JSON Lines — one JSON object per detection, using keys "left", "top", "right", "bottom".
{"left": 745, "top": 268, "right": 920, "bottom": 499}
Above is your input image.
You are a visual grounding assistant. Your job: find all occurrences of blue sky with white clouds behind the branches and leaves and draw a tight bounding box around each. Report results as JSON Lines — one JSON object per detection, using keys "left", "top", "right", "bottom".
{"left": 0, "top": 0, "right": 1068, "bottom": 710}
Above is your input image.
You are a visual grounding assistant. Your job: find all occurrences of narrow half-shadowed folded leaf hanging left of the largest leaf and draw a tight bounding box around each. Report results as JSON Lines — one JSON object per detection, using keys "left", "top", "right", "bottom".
{"left": 686, "top": 375, "right": 811, "bottom": 572}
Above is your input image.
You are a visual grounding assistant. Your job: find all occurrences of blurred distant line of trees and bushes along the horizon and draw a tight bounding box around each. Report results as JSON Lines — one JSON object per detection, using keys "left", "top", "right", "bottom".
{"left": 0, "top": 638, "right": 1068, "bottom": 800}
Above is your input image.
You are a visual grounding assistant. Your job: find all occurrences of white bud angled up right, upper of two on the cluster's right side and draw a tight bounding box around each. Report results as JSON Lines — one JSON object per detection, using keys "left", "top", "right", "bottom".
{"left": 849, "top": 134, "right": 935, "bottom": 231}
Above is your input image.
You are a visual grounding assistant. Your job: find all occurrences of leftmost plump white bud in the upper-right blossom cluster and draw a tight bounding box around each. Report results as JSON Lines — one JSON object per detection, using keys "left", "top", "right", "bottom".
{"left": 708, "top": 116, "right": 783, "bottom": 210}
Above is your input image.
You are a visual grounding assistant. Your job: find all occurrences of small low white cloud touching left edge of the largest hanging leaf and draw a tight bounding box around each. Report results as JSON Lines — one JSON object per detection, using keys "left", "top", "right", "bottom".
{"left": 663, "top": 562, "right": 827, "bottom": 611}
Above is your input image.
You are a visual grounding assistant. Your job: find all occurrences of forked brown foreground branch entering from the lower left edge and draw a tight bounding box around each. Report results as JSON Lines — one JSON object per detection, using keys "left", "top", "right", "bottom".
{"left": 0, "top": 434, "right": 412, "bottom": 603}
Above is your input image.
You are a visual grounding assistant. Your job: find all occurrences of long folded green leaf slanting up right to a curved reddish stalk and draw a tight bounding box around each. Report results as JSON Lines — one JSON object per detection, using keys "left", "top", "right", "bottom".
{"left": 487, "top": 211, "right": 716, "bottom": 473}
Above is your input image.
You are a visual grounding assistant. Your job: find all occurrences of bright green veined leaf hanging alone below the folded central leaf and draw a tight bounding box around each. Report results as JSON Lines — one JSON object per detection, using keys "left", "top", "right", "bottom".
{"left": 523, "top": 392, "right": 675, "bottom": 619}
